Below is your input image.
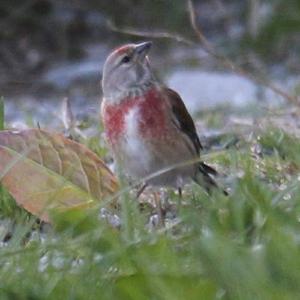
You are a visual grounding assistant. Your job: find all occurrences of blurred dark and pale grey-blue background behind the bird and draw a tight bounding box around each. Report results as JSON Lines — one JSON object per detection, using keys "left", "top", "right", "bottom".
{"left": 0, "top": 0, "right": 300, "bottom": 128}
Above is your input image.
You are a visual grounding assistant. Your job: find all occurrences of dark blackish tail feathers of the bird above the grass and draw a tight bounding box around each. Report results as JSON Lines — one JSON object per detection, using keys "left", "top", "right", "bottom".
{"left": 194, "top": 162, "right": 228, "bottom": 195}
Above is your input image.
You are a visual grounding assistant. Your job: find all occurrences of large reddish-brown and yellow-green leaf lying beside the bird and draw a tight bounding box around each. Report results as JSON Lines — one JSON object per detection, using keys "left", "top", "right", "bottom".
{"left": 0, "top": 129, "right": 118, "bottom": 221}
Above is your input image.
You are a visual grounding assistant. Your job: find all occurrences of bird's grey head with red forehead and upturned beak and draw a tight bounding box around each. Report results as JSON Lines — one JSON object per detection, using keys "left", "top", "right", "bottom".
{"left": 102, "top": 42, "right": 152, "bottom": 98}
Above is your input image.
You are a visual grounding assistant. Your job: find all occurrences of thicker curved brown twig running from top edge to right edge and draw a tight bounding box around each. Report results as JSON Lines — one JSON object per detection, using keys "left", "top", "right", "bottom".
{"left": 187, "top": 0, "right": 300, "bottom": 105}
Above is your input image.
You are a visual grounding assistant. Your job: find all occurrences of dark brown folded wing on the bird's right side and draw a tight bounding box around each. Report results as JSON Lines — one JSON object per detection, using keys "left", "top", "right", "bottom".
{"left": 163, "top": 88, "right": 202, "bottom": 155}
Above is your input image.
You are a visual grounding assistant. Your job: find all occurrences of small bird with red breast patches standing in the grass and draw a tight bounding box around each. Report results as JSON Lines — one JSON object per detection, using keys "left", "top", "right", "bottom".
{"left": 101, "top": 41, "right": 223, "bottom": 195}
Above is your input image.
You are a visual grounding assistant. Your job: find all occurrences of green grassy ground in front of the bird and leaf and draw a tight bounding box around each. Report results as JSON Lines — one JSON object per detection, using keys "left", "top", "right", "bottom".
{"left": 0, "top": 106, "right": 300, "bottom": 300}
